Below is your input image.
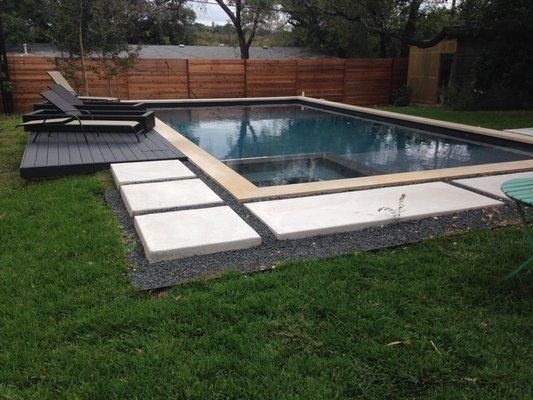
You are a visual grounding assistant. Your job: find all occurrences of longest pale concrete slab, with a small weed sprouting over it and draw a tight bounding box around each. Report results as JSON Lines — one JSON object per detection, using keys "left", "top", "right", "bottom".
{"left": 246, "top": 182, "right": 502, "bottom": 239}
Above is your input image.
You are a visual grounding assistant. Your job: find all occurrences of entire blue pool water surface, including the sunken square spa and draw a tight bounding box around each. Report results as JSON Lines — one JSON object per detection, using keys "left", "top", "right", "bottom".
{"left": 157, "top": 105, "right": 531, "bottom": 185}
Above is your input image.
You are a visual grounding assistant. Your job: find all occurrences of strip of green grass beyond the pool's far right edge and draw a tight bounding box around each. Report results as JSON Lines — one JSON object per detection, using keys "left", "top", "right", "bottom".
{"left": 383, "top": 106, "right": 533, "bottom": 130}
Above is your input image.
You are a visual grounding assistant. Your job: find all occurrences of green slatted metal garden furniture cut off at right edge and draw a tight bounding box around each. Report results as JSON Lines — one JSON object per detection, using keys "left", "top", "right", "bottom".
{"left": 501, "top": 178, "right": 533, "bottom": 278}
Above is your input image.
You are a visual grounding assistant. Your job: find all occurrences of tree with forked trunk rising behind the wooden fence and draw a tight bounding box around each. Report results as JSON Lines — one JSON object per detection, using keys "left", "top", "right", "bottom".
{"left": 206, "top": 0, "right": 277, "bottom": 59}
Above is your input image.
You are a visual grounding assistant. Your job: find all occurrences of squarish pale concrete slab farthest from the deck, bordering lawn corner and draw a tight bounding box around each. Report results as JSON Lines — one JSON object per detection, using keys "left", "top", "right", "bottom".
{"left": 134, "top": 206, "right": 261, "bottom": 262}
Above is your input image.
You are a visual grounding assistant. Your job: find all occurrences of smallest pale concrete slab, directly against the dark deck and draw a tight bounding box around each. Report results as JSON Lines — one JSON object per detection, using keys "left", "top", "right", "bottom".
{"left": 111, "top": 160, "right": 196, "bottom": 187}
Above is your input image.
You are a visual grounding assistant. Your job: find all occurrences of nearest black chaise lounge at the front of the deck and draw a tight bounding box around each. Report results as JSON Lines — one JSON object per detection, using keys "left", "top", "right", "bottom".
{"left": 18, "top": 90, "right": 146, "bottom": 142}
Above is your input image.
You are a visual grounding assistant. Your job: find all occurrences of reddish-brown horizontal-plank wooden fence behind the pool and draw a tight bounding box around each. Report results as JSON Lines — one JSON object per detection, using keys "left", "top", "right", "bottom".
{"left": 2, "top": 56, "right": 407, "bottom": 112}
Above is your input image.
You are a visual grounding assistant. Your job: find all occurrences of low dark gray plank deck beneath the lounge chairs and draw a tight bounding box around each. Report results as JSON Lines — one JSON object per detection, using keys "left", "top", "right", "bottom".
{"left": 20, "top": 131, "right": 187, "bottom": 179}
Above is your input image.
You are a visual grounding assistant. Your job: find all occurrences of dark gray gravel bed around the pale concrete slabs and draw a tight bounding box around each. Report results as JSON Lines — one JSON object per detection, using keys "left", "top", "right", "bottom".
{"left": 105, "top": 162, "right": 516, "bottom": 289}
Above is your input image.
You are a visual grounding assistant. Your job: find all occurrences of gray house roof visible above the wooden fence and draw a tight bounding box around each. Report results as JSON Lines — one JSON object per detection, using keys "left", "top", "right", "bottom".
{"left": 8, "top": 43, "right": 326, "bottom": 59}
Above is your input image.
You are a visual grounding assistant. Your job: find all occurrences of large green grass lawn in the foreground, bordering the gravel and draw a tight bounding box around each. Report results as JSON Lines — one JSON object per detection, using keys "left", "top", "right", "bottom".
{"left": 0, "top": 110, "right": 533, "bottom": 399}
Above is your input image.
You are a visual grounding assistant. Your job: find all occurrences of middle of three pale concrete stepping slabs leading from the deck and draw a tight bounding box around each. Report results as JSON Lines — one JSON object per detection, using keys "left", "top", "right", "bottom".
{"left": 120, "top": 179, "right": 223, "bottom": 216}
